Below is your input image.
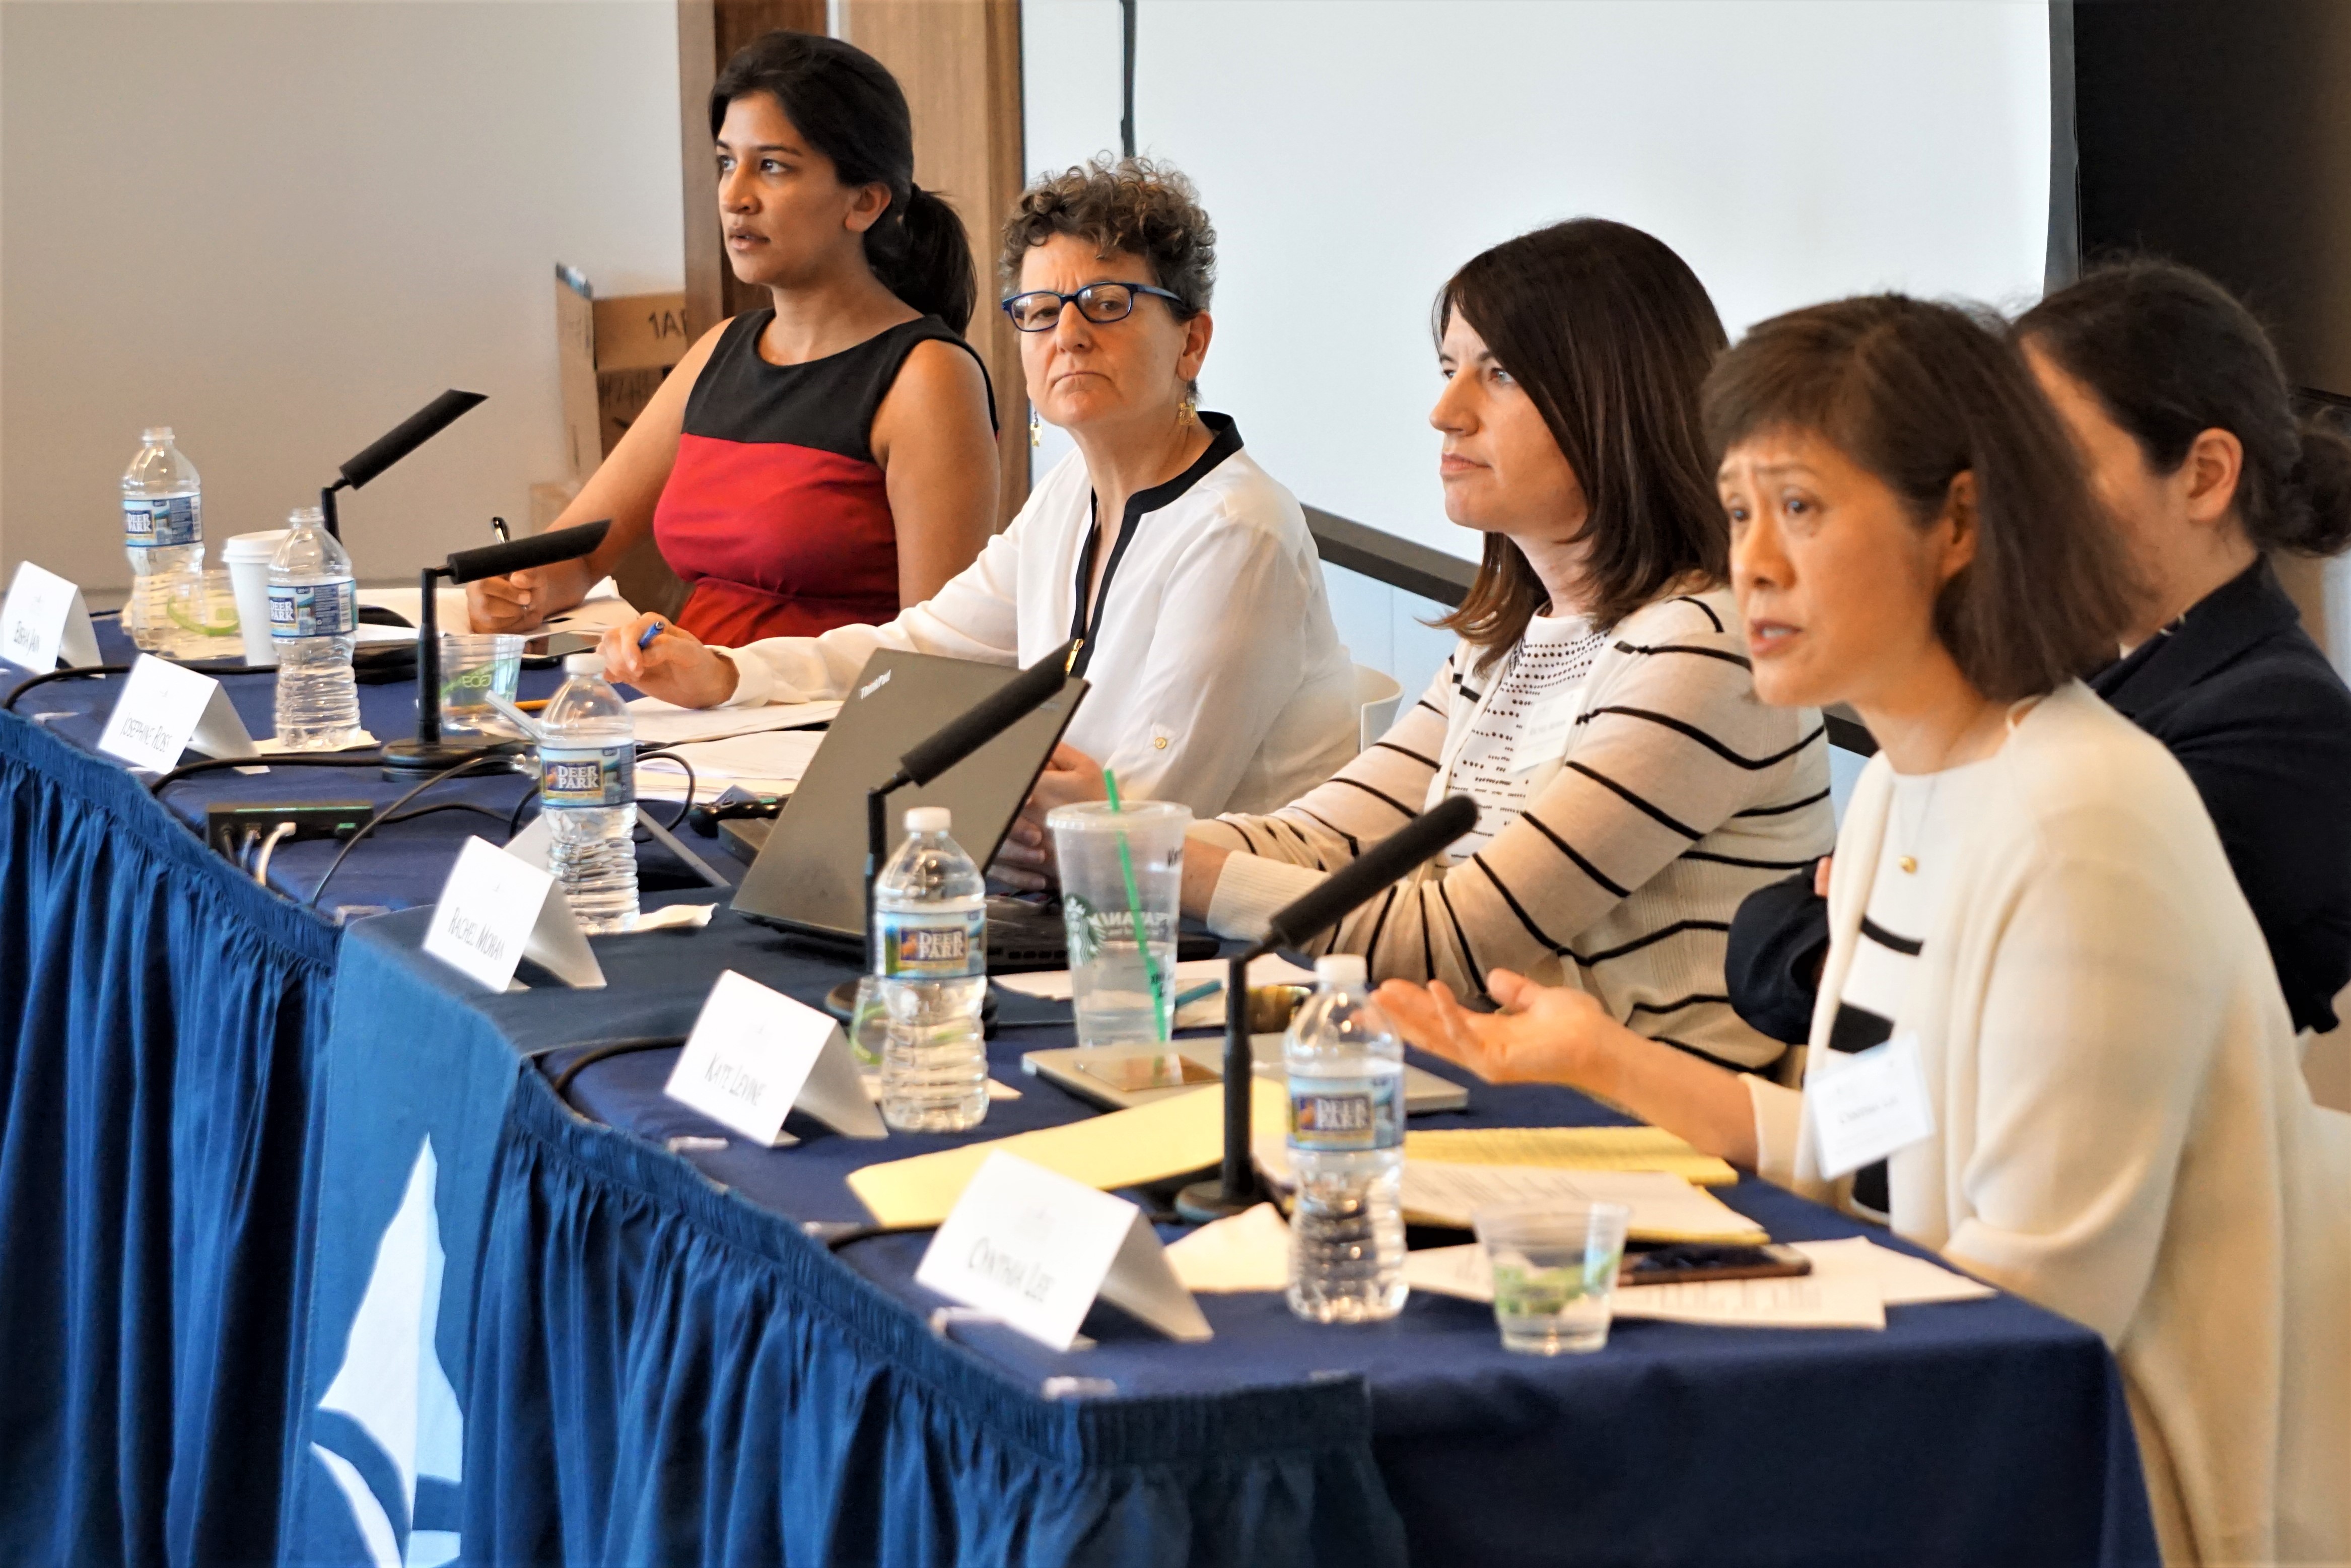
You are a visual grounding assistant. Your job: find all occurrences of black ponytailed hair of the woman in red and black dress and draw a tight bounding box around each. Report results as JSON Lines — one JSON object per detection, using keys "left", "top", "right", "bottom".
{"left": 710, "top": 33, "right": 981, "bottom": 331}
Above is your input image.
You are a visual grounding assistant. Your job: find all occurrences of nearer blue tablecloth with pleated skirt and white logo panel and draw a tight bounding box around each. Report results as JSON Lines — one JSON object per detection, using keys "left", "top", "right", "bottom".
{"left": 289, "top": 912, "right": 2154, "bottom": 1565}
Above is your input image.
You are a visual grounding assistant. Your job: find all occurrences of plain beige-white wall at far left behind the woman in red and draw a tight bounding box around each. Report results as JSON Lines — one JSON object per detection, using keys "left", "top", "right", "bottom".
{"left": 0, "top": 0, "right": 684, "bottom": 588}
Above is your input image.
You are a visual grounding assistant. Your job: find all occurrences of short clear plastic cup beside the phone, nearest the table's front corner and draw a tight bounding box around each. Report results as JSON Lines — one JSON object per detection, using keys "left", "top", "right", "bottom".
{"left": 1470, "top": 1201, "right": 1632, "bottom": 1356}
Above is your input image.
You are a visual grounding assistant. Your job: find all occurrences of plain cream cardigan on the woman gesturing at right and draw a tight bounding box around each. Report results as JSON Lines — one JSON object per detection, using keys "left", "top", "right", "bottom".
{"left": 1749, "top": 684, "right": 2351, "bottom": 1563}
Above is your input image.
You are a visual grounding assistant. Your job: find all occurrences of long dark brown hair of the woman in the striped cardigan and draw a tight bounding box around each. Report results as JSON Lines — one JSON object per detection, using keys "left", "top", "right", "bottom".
{"left": 1434, "top": 219, "right": 1731, "bottom": 667}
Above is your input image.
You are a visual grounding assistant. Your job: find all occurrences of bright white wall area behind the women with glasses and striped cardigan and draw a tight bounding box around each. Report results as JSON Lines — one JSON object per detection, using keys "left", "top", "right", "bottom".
{"left": 1023, "top": 0, "right": 2050, "bottom": 687}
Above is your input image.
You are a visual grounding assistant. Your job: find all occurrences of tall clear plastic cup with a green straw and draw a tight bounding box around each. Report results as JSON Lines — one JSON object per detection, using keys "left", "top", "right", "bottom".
{"left": 1044, "top": 799, "right": 1192, "bottom": 1046}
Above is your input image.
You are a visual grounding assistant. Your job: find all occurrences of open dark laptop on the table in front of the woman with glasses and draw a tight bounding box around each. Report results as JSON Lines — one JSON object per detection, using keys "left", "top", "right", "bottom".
{"left": 722, "top": 649, "right": 1215, "bottom": 973}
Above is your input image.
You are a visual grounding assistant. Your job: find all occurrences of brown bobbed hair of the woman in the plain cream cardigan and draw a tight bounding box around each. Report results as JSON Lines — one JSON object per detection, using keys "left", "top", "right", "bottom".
{"left": 1704, "top": 294, "right": 2130, "bottom": 703}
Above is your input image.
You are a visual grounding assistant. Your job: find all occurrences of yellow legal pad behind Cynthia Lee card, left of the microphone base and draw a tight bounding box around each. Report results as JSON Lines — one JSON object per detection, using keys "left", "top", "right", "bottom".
{"left": 849, "top": 1079, "right": 1291, "bottom": 1225}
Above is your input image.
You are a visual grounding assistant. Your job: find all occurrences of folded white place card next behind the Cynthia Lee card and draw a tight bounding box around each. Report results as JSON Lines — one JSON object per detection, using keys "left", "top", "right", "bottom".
{"left": 663, "top": 969, "right": 889, "bottom": 1147}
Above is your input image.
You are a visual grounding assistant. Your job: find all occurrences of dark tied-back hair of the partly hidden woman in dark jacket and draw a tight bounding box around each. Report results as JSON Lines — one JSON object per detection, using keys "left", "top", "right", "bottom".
{"left": 2015, "top": 258, "right": 2351, "bottom": 555}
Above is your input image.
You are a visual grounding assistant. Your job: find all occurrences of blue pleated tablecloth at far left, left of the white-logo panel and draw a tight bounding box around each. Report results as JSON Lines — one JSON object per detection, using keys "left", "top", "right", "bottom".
{"left": 0, "top": 618, "right": 686, "bottom": 1568}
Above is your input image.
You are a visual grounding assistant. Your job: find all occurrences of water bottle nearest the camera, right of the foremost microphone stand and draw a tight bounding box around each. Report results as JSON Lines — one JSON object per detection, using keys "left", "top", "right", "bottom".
{"left": 1281, "top": 952, "right": 1406, "bottom": 1324}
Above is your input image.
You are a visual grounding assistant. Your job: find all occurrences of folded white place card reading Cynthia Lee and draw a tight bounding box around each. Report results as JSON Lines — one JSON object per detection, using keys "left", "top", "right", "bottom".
{"left": 915, "top": 1149, "right": 1213, "bottom": 1352}
